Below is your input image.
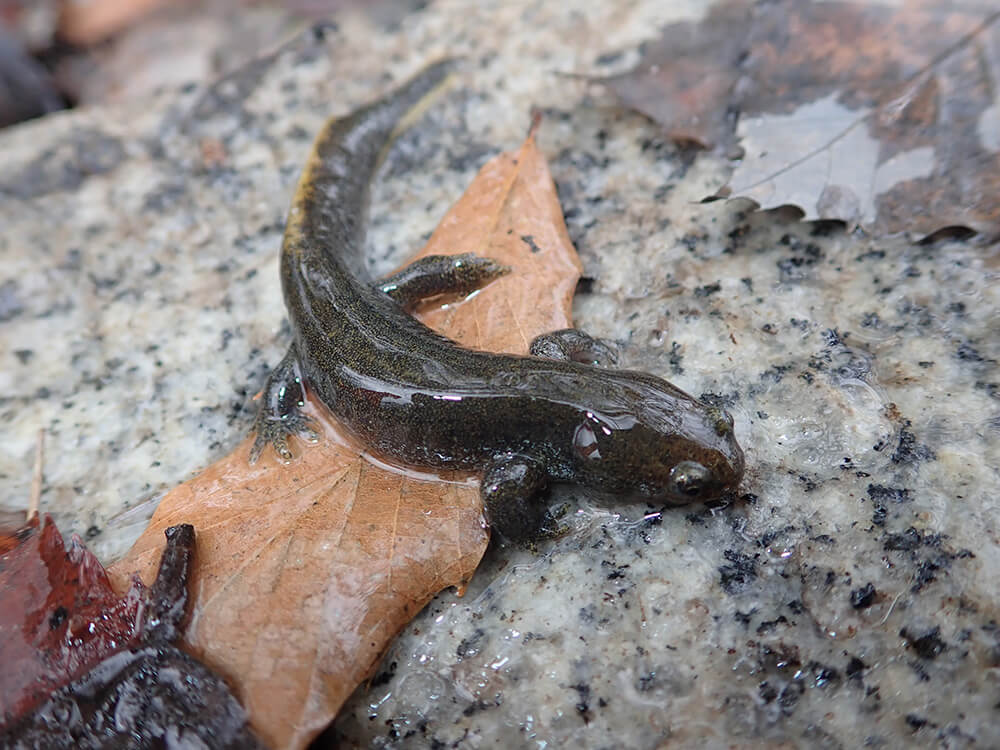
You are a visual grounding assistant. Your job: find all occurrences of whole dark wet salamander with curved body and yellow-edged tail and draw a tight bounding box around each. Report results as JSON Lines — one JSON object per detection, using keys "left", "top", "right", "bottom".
{"left": 251, "top": 62, "right": 743, "bottom": 540}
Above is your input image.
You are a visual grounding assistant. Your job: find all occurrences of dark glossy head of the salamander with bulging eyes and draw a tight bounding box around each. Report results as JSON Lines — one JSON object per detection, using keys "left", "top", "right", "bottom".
{"left": 572, "top": 372, "right": 744, "bottom": 505}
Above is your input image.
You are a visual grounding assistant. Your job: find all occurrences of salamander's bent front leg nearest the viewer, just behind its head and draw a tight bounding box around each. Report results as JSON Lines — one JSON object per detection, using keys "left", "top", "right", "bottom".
{"left": 480, "top": 455, "right": 564, "bottom": 544}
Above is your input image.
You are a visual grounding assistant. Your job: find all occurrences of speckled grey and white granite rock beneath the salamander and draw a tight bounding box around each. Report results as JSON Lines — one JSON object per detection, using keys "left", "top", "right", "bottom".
{"left": 0, "top": 1, "right": 1000, "bottom": 748}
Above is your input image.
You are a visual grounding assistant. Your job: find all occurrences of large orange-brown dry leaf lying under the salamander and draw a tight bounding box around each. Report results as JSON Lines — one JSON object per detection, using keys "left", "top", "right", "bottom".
{"left": 110, "top": 126, "right": 580, "bottom": 747}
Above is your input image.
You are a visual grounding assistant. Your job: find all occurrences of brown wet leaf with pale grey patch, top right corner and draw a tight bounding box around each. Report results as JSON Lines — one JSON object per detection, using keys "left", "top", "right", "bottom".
{"left": 608, "top": 0, "right": 1000, "bottom": 237}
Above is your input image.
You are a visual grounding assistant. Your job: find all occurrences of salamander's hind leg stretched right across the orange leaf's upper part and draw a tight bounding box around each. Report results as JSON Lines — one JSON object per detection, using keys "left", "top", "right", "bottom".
{"left": 378, "top": 253, "right": 510, "bottom": 308}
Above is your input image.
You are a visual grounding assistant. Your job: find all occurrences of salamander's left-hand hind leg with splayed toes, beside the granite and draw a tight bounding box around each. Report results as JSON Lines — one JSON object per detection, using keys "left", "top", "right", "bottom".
{"left": 250, "top": 346, "right": 319, "bottom": 463}
